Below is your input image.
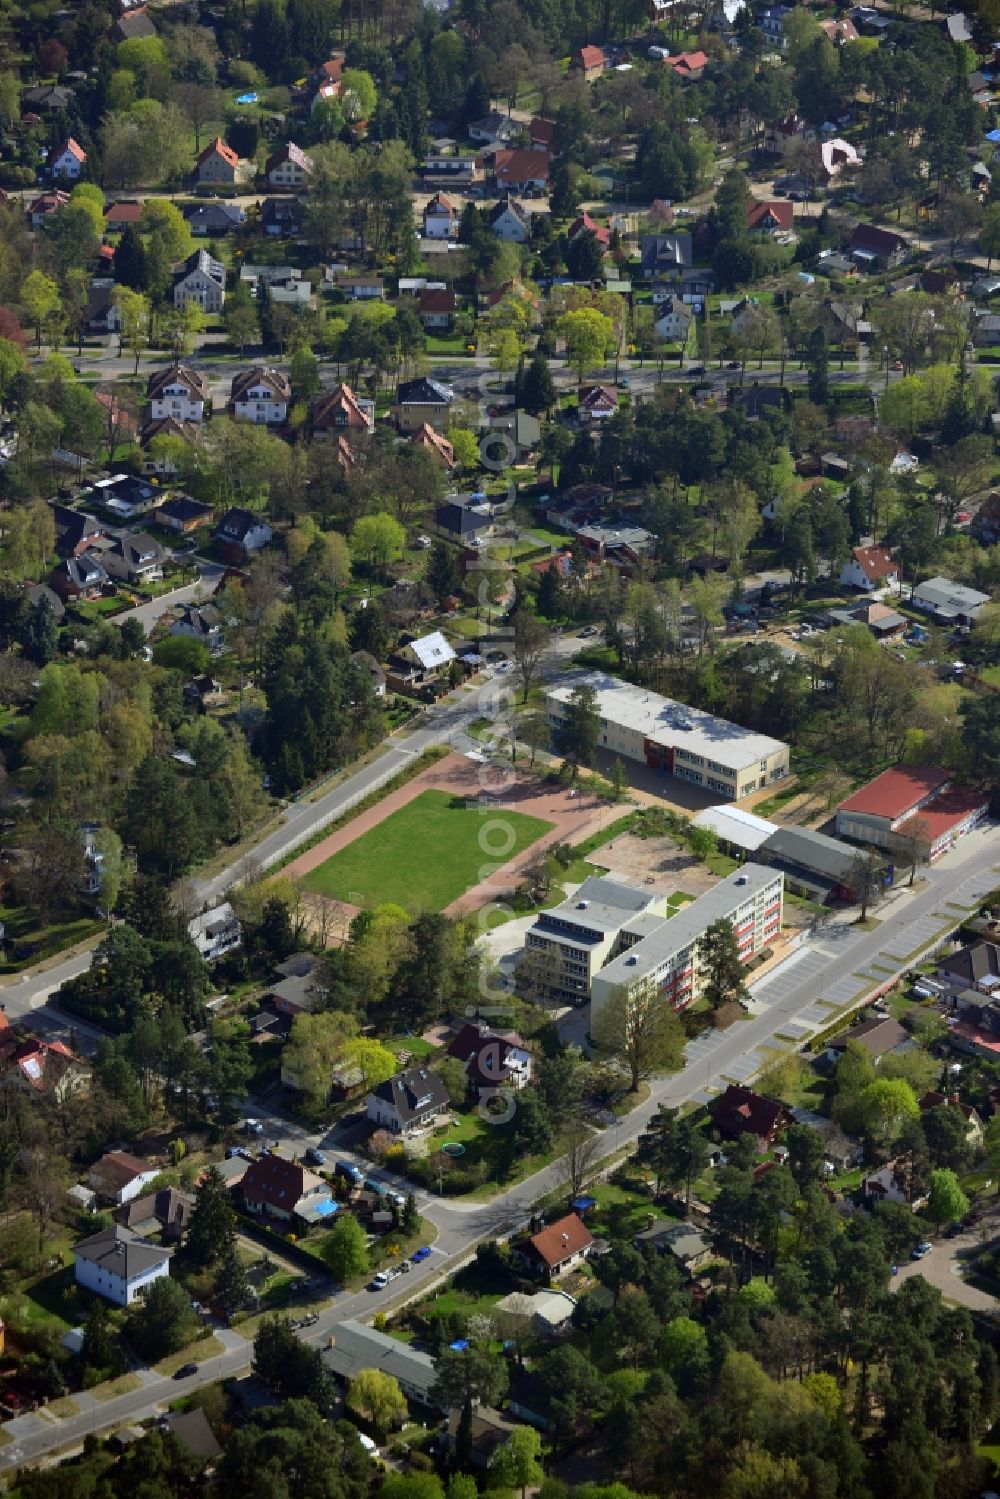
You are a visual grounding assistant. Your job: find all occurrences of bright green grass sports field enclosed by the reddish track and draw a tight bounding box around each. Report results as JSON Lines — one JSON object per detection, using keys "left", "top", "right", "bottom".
{"left": 304, "top": 791, "right": 552, "bottom": 911}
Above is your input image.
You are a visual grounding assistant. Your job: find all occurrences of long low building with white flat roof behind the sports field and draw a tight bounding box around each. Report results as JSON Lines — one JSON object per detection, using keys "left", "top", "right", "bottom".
{"left": 546, "top": 672, "right": 789, "bottom": 800}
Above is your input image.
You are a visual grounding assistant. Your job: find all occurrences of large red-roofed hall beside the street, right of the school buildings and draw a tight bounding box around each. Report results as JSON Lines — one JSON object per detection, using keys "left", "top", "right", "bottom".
{"left": 837, "top": 764, "right": 990, "bottom": 860}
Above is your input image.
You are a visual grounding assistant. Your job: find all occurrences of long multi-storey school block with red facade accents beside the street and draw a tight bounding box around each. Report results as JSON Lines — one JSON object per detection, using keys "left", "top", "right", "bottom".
{"left": 591, "top": 863, "right": 784, "bottom": 1025}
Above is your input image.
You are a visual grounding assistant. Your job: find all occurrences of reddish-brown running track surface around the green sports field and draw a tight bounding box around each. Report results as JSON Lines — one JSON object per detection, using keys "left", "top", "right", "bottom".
{"left": 283, "top": 754, "right": 619, "bottom": 943}
